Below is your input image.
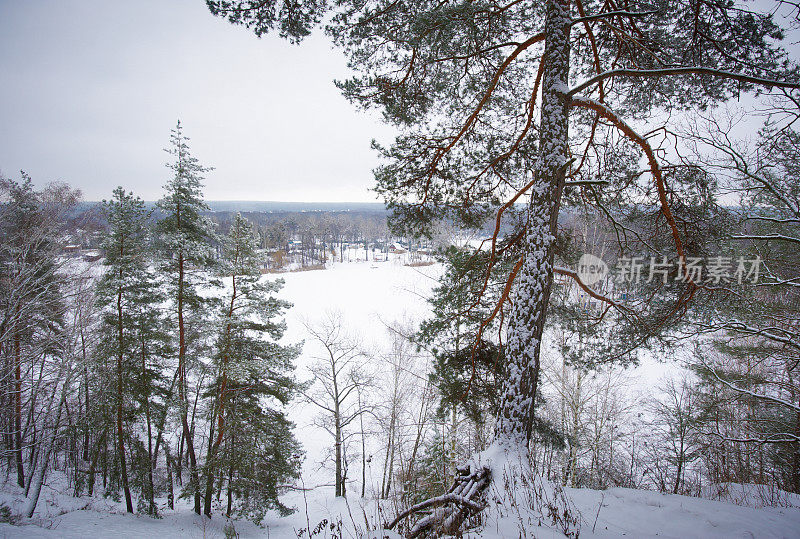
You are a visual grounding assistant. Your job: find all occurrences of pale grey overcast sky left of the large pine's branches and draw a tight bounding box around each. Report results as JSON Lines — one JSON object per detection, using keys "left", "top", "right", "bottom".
{"left": 0, "top": 0, "right": 392, "bottom": 202}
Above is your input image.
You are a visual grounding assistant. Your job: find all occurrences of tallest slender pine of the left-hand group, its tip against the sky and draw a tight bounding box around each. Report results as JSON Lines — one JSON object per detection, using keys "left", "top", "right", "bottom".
{"left": 156, "top": 122, "right": 216, "bottom": 515}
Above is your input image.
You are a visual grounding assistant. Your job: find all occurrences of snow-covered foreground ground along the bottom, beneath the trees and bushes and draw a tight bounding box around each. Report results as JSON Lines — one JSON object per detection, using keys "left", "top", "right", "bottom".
{"left": 0, "top": 472, "right": 800, "bottom": 539}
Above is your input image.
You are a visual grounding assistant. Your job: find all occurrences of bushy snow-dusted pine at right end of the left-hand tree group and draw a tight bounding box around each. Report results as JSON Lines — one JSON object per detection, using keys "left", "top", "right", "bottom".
{"left": 204, "top": 214, "right": 300, "bottom": 521}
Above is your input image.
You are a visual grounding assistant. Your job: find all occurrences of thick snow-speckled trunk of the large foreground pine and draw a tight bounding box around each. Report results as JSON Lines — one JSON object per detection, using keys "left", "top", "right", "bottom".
{"left": 495, "top": 0, "right": 570, "bottom": 448}
